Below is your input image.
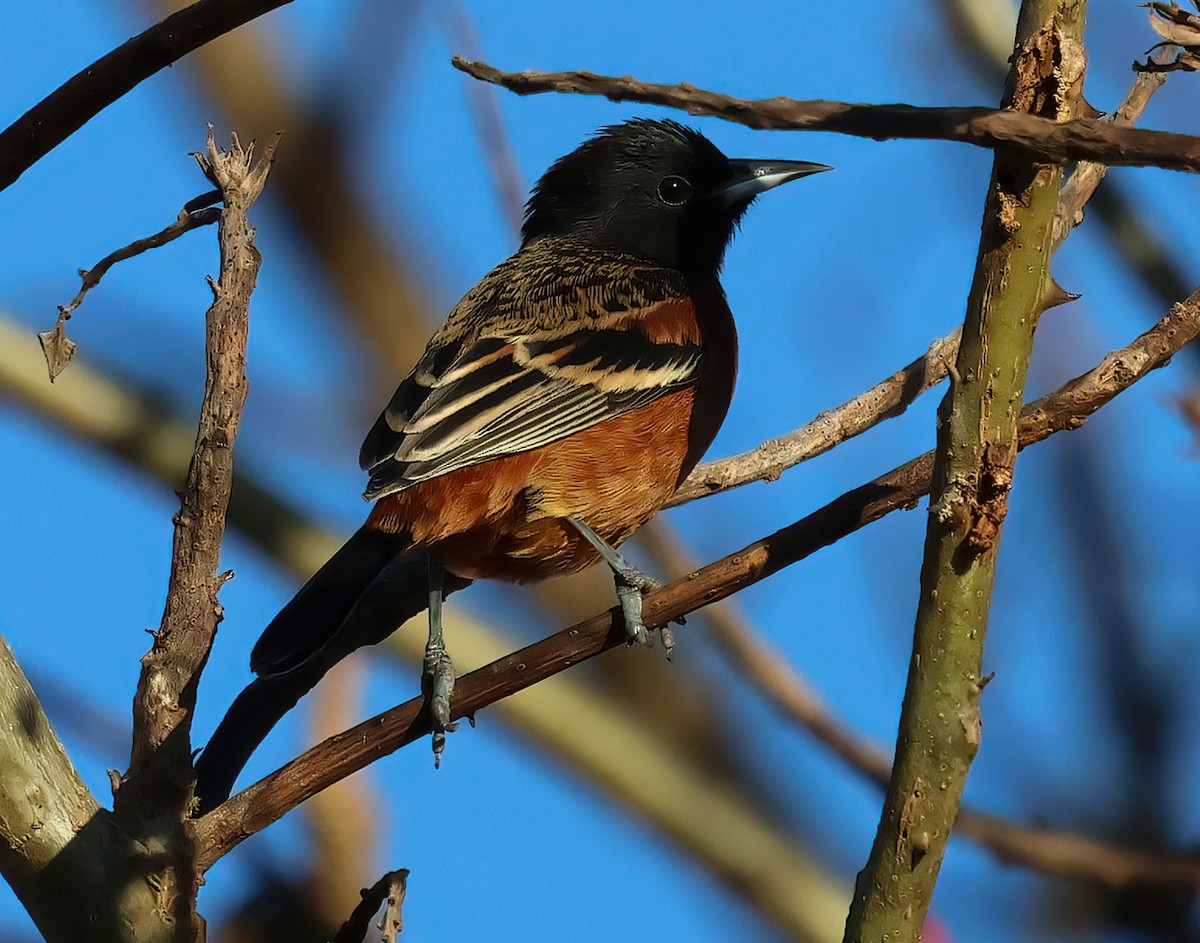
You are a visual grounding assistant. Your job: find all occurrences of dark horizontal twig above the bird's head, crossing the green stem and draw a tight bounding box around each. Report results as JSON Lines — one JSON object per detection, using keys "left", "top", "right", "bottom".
{"left": 452, "top": 56, "right": 1200, "bottom": 173}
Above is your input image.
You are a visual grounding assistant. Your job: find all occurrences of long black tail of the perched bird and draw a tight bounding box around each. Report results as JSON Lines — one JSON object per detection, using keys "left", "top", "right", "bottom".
{"left": 196, "top": 528, "right": 469, "bottom": 811}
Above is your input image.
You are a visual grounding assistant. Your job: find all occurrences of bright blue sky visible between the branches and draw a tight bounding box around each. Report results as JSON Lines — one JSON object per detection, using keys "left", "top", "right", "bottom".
{"left": 0, "top": 0, "right": 1200, "bottom": 943}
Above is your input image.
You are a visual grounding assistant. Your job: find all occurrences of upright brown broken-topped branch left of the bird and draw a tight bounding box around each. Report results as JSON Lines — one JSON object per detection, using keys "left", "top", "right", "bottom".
{"left": 114, "top": 128, "right": 276, "bottom": 939}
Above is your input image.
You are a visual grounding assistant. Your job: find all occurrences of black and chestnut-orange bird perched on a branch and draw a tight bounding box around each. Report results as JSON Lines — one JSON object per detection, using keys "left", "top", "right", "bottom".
{"left": 196, "top": 118, "right": 830, "bottom": 810}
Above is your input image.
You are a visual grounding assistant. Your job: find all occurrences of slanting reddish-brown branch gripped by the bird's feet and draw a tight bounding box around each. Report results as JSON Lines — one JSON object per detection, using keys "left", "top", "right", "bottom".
{"left": 193, "top": 293, "right": 1200, "bottom": 869}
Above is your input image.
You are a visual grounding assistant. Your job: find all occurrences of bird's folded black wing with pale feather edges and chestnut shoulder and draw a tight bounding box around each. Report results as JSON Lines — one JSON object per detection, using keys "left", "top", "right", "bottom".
{"left": 360, "top": 307, "right": 703, "bottom": 498}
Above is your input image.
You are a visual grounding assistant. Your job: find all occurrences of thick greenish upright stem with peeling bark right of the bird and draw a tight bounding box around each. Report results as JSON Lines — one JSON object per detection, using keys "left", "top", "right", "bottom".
{"left": 845, "top": 0, "right": 1085, "bottom": 943}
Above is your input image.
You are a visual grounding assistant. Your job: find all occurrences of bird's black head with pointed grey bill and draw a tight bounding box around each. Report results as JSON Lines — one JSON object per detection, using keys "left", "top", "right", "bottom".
{"left": 521, "top": 119, "right": 829, "bottom": 276}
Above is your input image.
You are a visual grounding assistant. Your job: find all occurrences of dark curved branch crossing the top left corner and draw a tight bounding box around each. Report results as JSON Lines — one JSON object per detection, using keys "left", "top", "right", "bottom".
{"left": 0, "top": 0, "right": 292, "bottom": 190}
